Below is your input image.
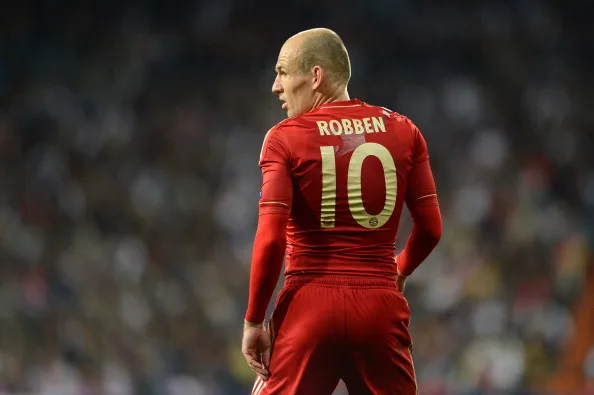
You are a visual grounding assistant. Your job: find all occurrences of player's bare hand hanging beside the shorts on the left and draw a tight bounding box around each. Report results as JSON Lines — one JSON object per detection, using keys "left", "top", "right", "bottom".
{"left": 241, "top": 321, "right": 272, "bottom": 381}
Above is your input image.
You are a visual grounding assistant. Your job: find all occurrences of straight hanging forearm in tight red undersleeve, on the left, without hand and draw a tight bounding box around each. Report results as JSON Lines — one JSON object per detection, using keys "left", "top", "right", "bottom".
{"left": 245, "top": 214, "right": 288, "bottom": 324}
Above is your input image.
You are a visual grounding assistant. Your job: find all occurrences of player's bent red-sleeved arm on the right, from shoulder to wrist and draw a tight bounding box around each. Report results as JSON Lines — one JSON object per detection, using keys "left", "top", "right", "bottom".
{"left": 396, "top": 123, "right": 442, "bottom": 277}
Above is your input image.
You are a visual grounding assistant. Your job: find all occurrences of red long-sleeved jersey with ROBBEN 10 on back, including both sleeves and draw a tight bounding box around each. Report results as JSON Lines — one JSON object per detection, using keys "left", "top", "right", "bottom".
{"left": 246, "top": 100, "right": 441, "bottom": 323}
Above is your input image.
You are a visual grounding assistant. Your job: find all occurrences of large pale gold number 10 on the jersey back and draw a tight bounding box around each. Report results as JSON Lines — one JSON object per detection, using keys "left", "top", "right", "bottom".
{"left": 320, "top": 143, "right": 397, "bottom": 229}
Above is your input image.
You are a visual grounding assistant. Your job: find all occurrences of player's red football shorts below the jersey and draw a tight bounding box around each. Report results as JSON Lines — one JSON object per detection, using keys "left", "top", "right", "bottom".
{"left": 252, "top": 275, "right": 417, "bottom": 395}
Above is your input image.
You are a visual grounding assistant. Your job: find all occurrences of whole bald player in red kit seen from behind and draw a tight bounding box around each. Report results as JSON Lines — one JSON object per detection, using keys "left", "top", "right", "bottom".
{"left": 242, "top": 29, "right": 442, "bottom": 395}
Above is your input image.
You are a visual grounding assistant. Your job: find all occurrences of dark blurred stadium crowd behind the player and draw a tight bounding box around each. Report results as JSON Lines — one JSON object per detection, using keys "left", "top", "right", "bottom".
{"left": 0, "top": 0, "right": 594, "bottom": 395}
